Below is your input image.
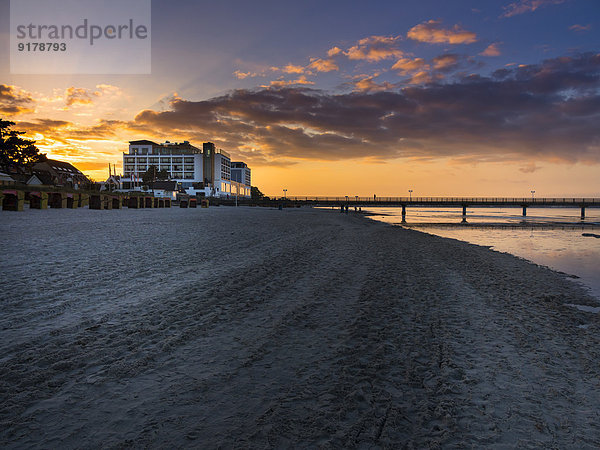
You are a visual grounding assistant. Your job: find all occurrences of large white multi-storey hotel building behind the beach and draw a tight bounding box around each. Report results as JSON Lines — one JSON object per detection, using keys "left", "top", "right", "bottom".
{"left": 121, "top": 140, "right": 251, "bottom": 198}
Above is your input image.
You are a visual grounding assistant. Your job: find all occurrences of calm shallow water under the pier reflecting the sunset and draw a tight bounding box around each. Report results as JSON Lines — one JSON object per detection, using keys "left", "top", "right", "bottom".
{"left": 364, "top": 207, "right": 600, "bottom": 300}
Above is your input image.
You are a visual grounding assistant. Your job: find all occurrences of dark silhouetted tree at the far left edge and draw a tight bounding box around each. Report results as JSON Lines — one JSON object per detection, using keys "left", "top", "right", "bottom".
{"left": 0, "top": 119, "right": 47, "bottom": 172}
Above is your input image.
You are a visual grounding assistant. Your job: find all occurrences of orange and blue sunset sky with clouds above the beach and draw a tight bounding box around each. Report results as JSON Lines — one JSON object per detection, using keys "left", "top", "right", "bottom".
{"left": 0, "top": 0, "right": 600, "bottom": 197}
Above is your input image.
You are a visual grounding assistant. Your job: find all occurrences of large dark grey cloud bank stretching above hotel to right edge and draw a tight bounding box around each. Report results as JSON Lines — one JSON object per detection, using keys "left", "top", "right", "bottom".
{"left": 127, "top": 53, "right": 600, "bottom": 164}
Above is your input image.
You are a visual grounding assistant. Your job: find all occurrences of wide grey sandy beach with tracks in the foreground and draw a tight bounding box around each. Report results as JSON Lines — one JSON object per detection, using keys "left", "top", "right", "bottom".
{"left": 0, "top": 207, "right": 600, "bottom": 448}
